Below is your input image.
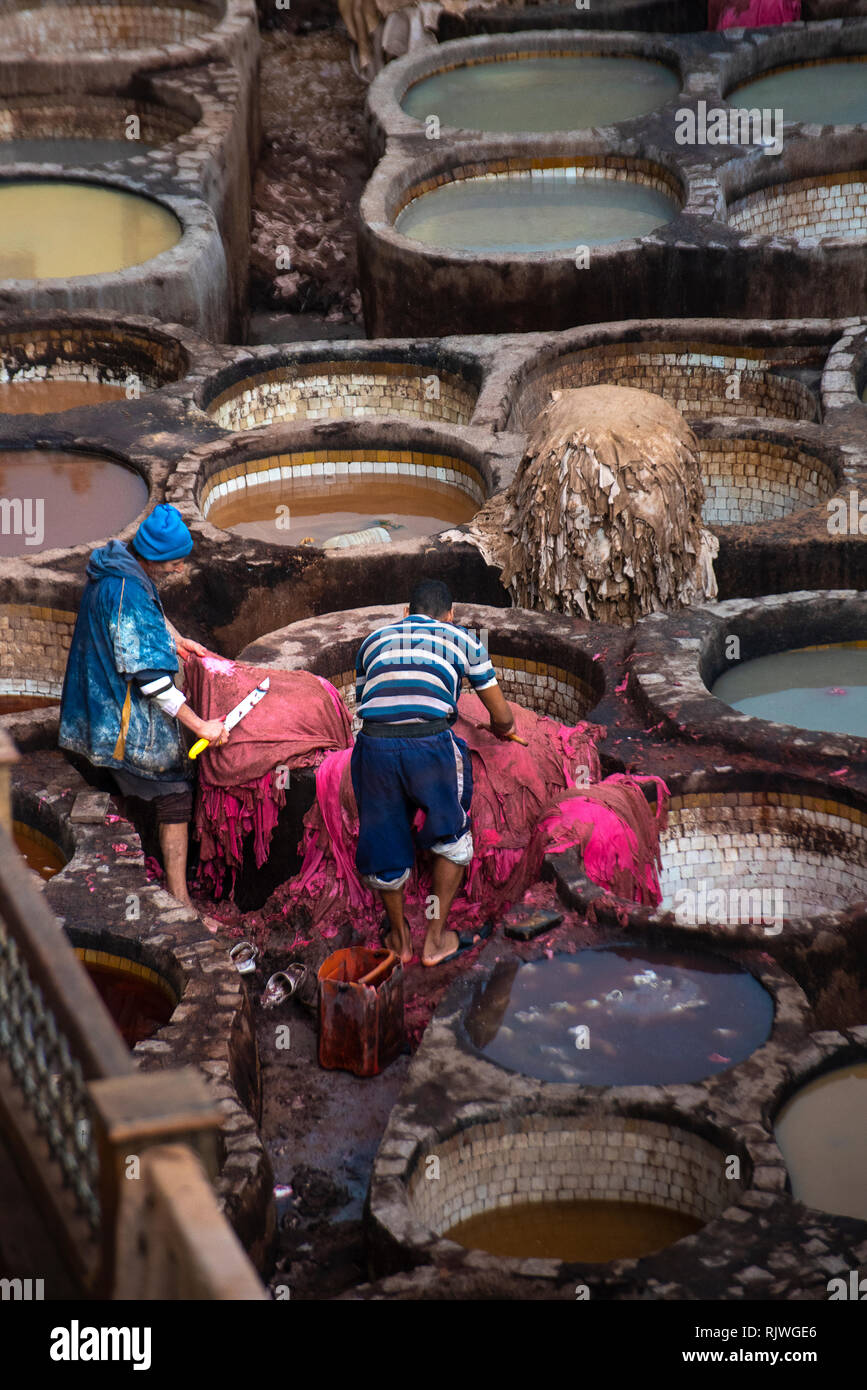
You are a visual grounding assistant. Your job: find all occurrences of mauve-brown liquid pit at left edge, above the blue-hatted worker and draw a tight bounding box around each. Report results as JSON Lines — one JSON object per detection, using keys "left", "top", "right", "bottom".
{"left": 0, "top": 449, "right": 147, "bottom": 557}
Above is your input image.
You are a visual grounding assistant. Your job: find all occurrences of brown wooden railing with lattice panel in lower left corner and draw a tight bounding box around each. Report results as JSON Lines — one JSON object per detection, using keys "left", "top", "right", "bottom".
{"left": 0, "top": 735, "right": 265, "bottom": 1298}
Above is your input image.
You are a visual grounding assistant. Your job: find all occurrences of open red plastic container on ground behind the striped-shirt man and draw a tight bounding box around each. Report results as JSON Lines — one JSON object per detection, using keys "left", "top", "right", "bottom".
{"left": 318, "top": 947, "right": 406, "bottom": 1076}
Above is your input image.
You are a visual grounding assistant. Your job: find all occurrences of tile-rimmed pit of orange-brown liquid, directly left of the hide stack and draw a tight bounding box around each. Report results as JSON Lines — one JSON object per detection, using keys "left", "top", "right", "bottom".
{"left": 200, "top": 450, "right": 485, "bottom": 545}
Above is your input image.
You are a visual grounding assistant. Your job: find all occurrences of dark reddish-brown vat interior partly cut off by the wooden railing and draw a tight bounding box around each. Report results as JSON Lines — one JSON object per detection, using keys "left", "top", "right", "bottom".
{"left": 67, "top": 927, "right": 183, "bottom": 1048}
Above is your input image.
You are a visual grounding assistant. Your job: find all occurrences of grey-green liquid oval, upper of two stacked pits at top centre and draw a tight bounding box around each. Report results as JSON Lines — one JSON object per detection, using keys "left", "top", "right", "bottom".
{"left": 402, "top": 54, "right": 679, "bottom": 131}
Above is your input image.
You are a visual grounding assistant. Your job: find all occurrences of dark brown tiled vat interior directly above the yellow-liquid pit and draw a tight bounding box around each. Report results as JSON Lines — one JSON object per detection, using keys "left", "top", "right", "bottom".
{"left": 0, "top": 92, "right": 195, "bottom": 167}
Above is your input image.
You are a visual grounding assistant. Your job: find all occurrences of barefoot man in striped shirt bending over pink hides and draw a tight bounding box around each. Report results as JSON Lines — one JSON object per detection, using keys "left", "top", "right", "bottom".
{"left": 352, "top": 580, "right": 514, "bottom": 966}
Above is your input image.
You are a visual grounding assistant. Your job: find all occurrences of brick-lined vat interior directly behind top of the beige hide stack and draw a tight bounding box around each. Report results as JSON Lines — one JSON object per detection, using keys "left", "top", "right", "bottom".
{"left": 510, "top": 339, "right": 818, "bottom": 430}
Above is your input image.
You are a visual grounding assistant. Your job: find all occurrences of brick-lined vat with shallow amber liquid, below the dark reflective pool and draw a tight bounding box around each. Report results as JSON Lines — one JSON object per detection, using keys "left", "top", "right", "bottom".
{"left": 407, "top": 1115, "right": 743, "bottom": 1264}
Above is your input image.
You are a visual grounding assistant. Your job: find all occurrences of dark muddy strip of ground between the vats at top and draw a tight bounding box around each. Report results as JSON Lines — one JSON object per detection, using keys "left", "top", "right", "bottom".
{"left": 250, "top": 28, "right": 368, "bottom": 338}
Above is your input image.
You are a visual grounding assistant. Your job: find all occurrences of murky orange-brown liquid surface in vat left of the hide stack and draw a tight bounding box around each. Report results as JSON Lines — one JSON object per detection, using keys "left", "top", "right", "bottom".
{"left": 208, "top": 475, "right": 478, "bottom": 545}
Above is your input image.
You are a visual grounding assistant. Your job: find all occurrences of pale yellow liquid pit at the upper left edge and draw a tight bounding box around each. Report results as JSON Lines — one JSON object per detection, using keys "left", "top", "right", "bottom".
{"left": 0, "top": 179, "right": 182, "bottom": 279}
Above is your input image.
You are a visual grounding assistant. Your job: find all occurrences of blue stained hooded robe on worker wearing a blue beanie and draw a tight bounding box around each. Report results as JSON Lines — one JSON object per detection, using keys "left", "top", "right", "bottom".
{"left": 58, "top": 541, "right": 190, "bottom": 780}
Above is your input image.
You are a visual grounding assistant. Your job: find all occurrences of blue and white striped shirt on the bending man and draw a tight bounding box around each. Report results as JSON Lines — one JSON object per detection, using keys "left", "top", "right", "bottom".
{"left": 356, "top": 613, "right": 496, "bottom": 724}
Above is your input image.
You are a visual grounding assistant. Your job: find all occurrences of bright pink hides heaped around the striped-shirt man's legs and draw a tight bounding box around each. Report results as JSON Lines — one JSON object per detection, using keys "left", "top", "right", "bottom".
{"left": 275, "top": 695, "right": 667, "bottom": 937}
